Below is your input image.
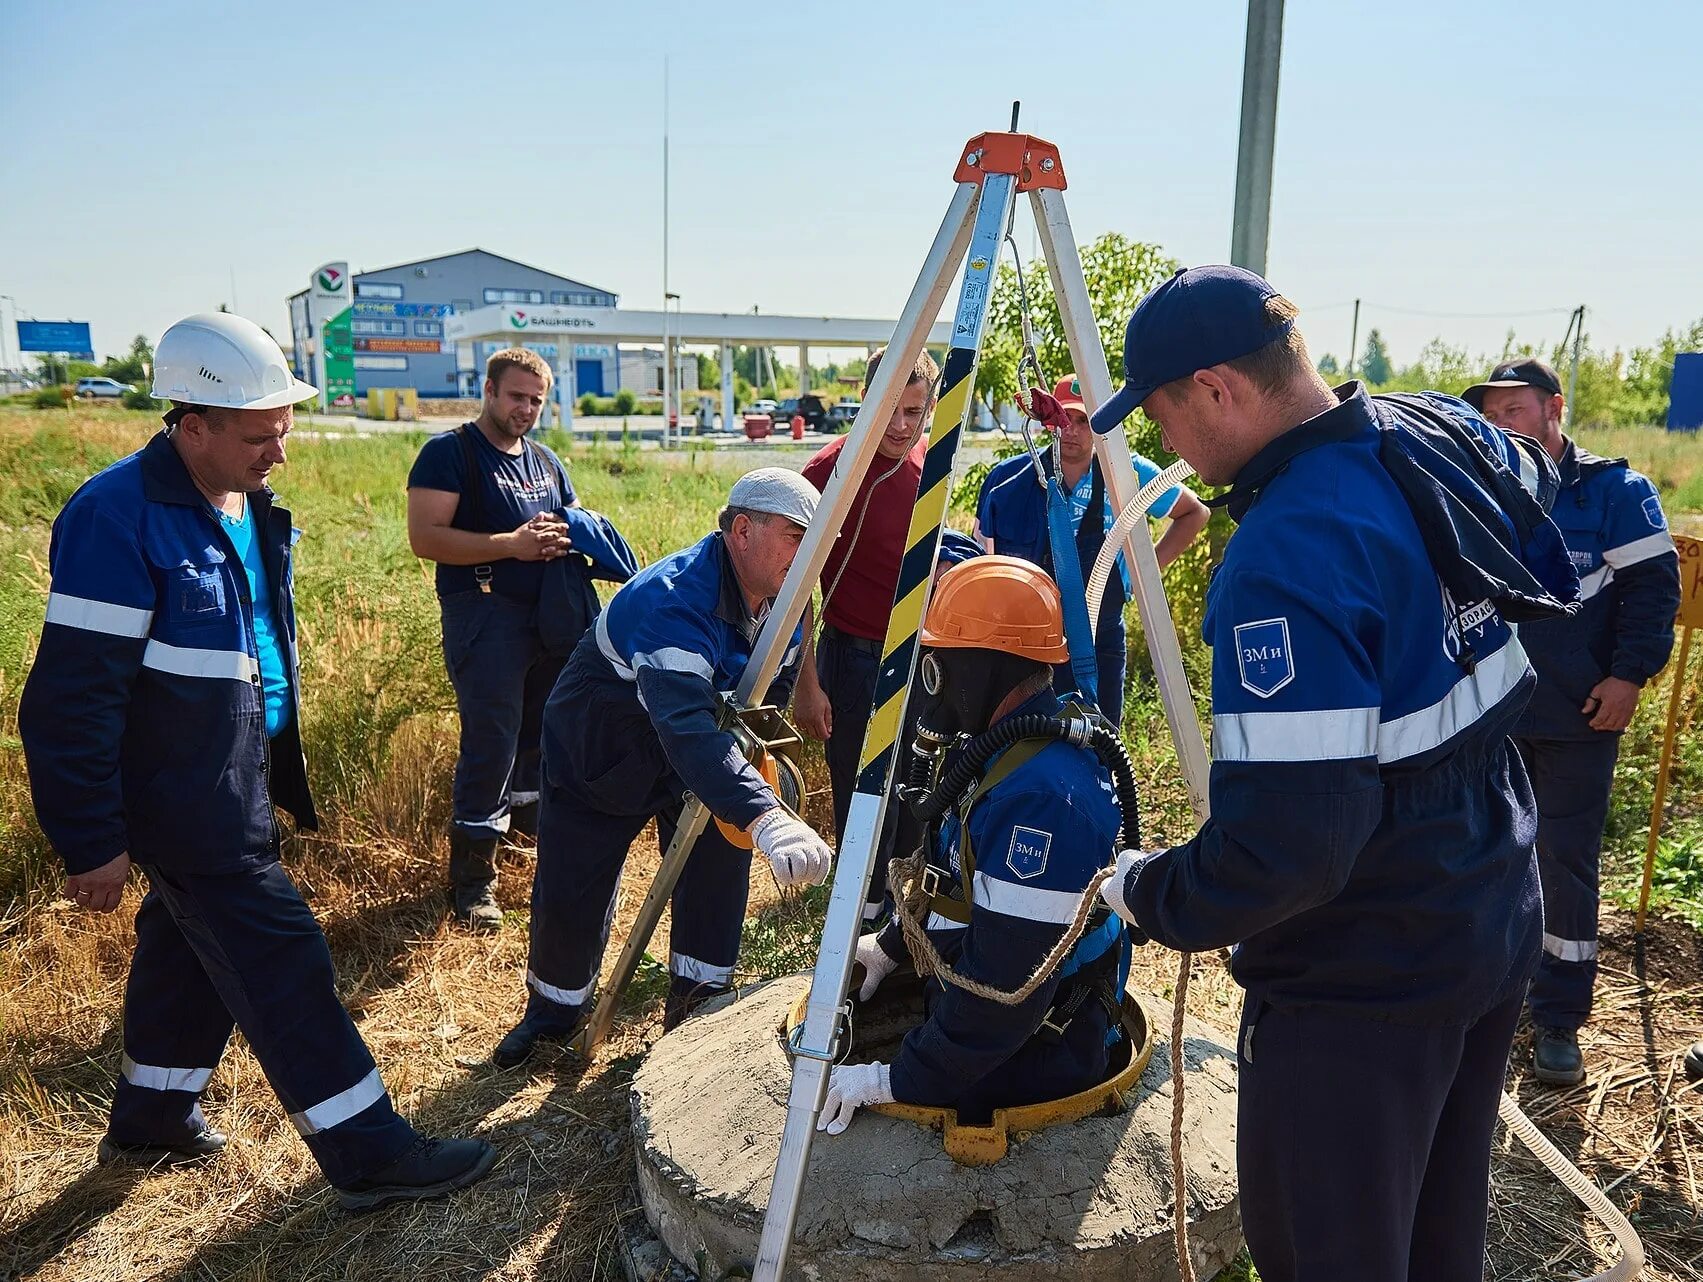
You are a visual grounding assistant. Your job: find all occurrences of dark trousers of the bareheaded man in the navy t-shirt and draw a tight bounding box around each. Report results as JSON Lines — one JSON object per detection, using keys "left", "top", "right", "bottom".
{"left": 439, "top": 591, "right": 564, "bottom": 839}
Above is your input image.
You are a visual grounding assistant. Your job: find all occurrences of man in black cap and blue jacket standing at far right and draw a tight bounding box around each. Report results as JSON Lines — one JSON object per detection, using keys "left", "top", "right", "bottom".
{"left": 1465, "top": 359, "right": 1679, "bottom": 1086}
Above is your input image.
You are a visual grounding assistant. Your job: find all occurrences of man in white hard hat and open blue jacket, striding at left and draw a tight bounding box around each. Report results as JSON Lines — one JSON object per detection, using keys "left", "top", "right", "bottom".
{"left": 19, "top": 315, "right": 496, "bottom": 1210}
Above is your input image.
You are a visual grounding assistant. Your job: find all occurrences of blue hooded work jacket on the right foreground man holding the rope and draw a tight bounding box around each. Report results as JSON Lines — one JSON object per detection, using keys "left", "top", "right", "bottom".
{"left": 1119, "top": 385, "right": 1577, "bottom": 1023}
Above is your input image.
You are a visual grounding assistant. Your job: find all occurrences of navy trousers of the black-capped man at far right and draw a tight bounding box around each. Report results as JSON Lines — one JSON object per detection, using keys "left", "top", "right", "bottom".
{"left": 1514, "top": 734, "right": 1620, "bottom": 1028}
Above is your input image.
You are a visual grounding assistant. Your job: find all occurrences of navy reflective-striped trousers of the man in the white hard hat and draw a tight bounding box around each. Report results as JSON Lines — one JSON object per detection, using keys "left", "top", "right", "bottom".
{"left": 109, "top": 863, "right": 416, "bottom": 1185}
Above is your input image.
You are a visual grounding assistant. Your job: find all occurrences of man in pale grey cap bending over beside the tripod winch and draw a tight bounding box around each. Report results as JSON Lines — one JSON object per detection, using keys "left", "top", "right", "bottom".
{"left": 490, "top": 468, "right": 831, "bottom": 1067}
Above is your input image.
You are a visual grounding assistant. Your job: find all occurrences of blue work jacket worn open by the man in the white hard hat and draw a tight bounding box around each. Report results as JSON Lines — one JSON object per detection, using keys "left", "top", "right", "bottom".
{"left": 19, "top": 432, "right": 317, "bottom": 873}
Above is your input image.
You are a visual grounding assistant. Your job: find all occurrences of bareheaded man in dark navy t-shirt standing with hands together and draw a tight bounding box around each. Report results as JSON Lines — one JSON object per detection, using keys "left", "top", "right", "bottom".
{"left": 409, "top": 347, "right": 579, "bottom": 930}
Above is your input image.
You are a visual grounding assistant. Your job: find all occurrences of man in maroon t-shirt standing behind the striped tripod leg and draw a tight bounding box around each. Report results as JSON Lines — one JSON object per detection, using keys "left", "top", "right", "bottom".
{"left": 792, "top": 351, "right": 976, "bottom": 919}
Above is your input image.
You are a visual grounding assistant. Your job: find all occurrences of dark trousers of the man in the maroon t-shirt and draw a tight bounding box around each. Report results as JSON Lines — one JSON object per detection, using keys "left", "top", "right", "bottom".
{"left": 816, "top": 628, "right": 923, "bottom": 921}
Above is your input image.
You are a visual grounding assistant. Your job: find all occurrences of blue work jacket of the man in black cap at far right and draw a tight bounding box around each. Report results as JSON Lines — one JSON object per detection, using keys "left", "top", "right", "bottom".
{"left": 1516, "top": 441, "right": 1679, "bottom": 739}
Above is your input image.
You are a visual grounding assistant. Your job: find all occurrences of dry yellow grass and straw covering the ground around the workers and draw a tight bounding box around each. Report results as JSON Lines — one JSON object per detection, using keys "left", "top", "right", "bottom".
{"left": 0, "top": 415, "right": 1703, "bottom": 1282}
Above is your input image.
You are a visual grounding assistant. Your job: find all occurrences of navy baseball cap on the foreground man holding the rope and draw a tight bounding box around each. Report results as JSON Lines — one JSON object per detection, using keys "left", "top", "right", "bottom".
{"left": 1092, "top": 264, "right": 1294, "bottom": 432}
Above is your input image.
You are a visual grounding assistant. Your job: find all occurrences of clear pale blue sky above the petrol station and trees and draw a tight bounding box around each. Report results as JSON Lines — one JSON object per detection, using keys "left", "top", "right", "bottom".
{"left": 0, "top": 0, "right": 1703, "bottom": 369}
